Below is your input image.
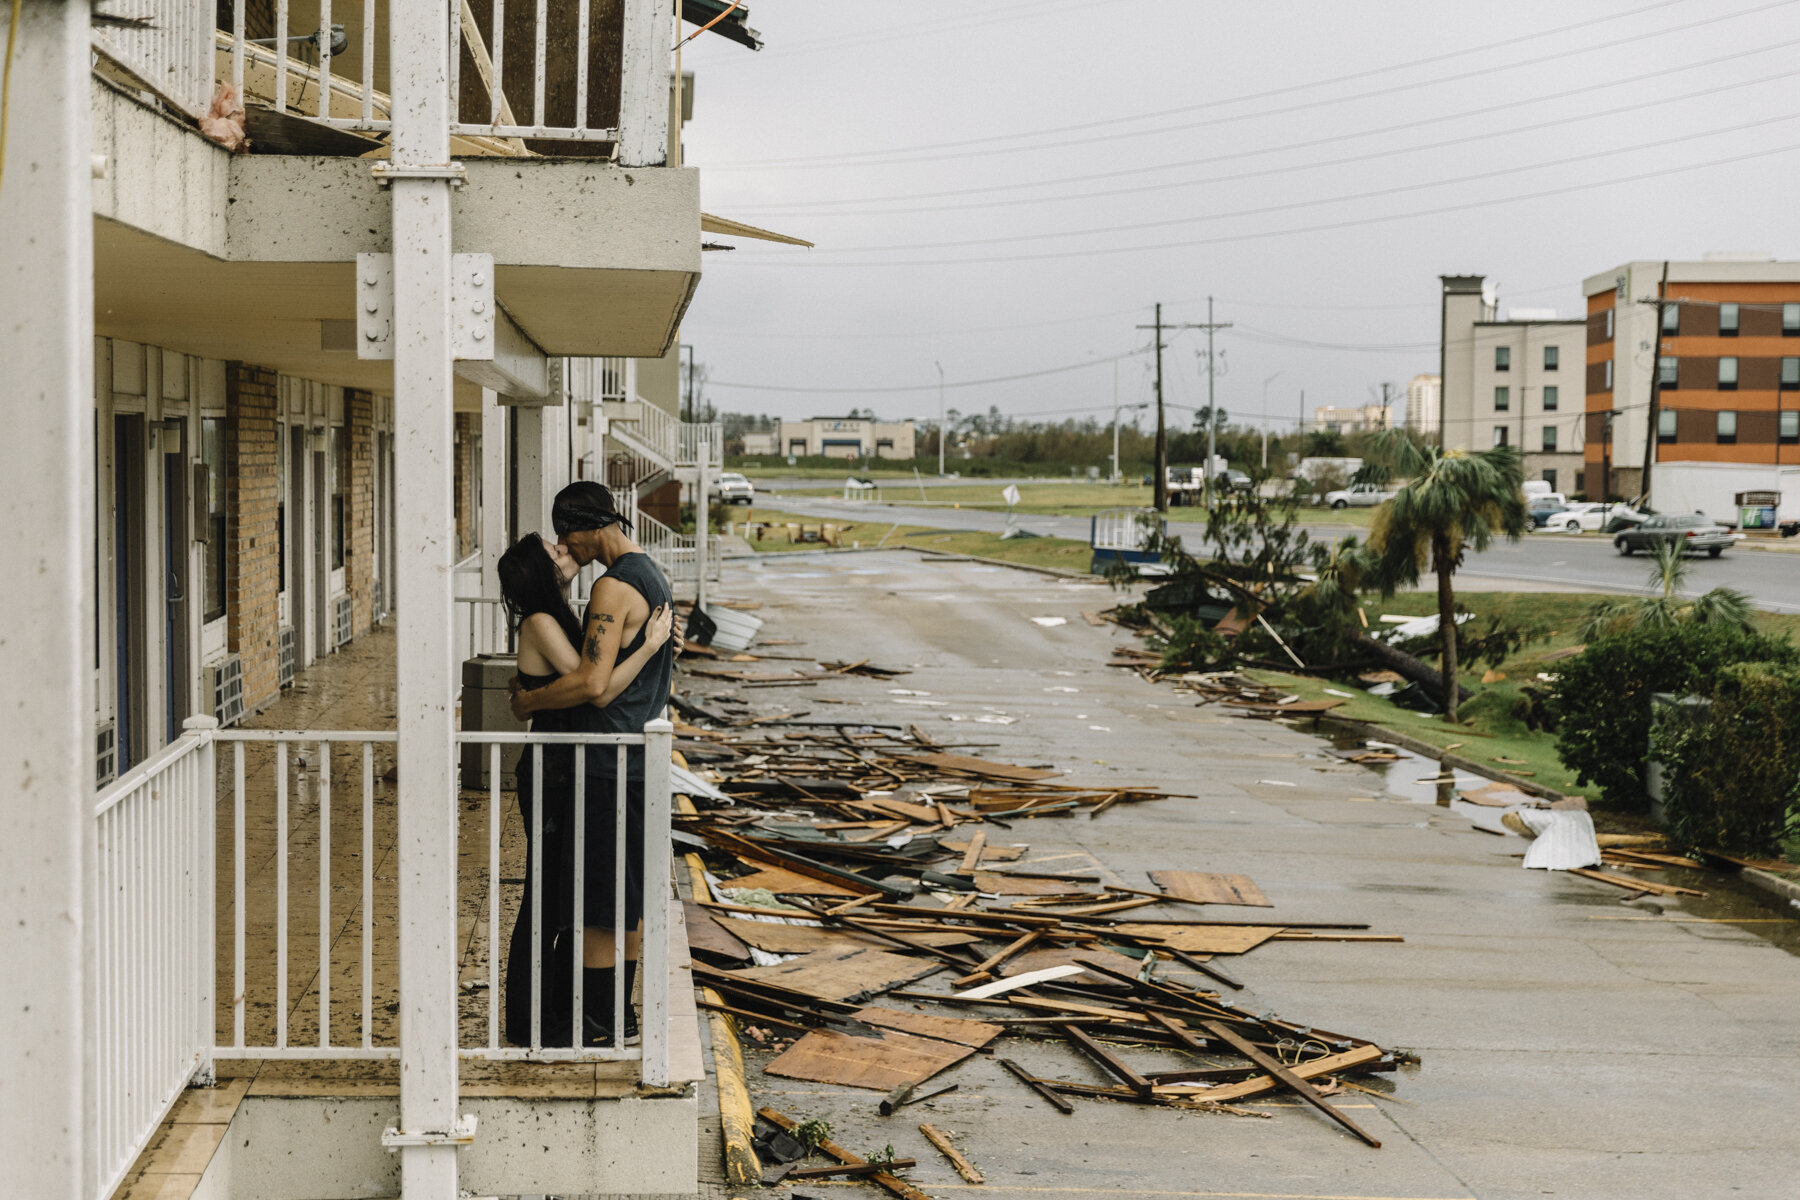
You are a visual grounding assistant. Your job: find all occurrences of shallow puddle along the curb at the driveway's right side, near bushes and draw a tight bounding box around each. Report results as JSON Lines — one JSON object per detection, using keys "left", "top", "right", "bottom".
{"left": 1307, "top": 732, "right": 1800, "bottom": 955}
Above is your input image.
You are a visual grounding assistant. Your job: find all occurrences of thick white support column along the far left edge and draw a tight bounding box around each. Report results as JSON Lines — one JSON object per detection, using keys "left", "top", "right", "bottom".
{"left": 0, "top": 0, "right": 99, "bottom": 1200}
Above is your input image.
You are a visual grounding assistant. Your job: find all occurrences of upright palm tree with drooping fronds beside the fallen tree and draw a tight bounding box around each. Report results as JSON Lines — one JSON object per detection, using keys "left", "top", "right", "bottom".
{"left": 1368, "top": 430, "right": 1532, "bottom": 723}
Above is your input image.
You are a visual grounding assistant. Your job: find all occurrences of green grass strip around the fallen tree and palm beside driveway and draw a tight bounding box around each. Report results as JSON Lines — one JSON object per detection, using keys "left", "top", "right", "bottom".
{"left": 1249, "top": 592, "right": 1800, "bottom": 813}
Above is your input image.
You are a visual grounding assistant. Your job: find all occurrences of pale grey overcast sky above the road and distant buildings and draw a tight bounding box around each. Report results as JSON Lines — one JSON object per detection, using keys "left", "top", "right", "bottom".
{"left": 682, "top": 0, "right": 1800, "bottom": 426}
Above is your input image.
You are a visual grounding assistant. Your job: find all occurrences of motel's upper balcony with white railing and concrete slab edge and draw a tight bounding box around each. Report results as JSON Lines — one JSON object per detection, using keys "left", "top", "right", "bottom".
{"left": 94, "top": 0, "right": 700, "bottom": 394}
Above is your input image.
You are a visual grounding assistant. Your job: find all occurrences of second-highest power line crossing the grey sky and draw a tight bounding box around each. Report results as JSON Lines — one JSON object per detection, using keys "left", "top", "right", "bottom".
{"left": 731, "top": 58, "right": 1800, "bottom": 218}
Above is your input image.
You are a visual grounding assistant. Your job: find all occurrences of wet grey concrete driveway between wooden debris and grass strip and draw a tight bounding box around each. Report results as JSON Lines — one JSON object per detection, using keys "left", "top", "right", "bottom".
{"left": 682, "top": 552, "right": 1800, "bottom": 1200}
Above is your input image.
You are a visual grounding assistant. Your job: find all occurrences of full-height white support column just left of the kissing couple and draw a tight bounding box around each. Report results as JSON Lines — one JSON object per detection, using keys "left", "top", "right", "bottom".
{"left": 383, "top": 4, "right": 459, "bottom": 1200}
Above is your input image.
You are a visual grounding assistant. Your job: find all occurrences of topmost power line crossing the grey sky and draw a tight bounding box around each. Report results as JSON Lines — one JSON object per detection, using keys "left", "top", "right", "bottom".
{"left": 709, "top": 0, "right": 1796, "bottom": 171}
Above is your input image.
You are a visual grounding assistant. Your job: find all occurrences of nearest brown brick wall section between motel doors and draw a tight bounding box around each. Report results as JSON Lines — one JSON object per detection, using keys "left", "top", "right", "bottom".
{"left": 225, "top": 362, "right": 281, "bottom": 712}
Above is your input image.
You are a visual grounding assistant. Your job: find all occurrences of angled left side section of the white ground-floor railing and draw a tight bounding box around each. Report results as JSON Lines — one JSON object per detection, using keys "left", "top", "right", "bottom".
{"left": 94, "top": 718, "right": 218, "bottom": 1196}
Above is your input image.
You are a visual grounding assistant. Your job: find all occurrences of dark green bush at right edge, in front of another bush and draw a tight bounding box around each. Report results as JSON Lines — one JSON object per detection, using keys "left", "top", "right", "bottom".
{"left": 1652, "top": 662, "right": 1800, "bottom": 855}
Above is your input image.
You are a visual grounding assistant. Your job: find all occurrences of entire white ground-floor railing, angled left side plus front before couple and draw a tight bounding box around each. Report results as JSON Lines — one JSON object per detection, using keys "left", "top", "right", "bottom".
{"left": 94, "top": 718, "right": 671, "bottom": 1196}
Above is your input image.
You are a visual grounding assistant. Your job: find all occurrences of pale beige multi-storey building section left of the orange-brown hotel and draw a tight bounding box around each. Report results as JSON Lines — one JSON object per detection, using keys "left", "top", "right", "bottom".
{"left": 1442, "top": 275, "right": 1588, "bottom": 491}
